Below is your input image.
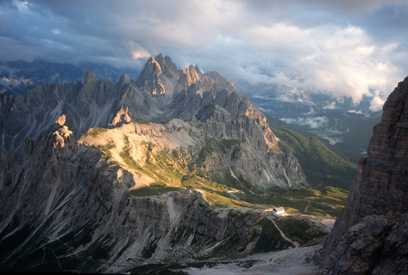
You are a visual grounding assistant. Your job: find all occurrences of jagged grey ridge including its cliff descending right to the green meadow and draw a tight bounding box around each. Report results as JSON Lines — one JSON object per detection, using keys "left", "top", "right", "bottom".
{"left": 0, "top": 55, "right": 307, "bottom": 191}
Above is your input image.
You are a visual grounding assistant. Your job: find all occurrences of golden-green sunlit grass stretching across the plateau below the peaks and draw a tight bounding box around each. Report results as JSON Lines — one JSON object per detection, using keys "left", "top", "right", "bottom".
{"left": 86, "top": 128, "right": 348, "bottom": 219}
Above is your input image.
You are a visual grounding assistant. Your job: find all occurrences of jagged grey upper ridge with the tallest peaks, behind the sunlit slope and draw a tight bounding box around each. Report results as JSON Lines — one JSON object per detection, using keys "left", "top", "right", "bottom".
{"left": 0, "top": 55, "right": 273, "bottom": 155}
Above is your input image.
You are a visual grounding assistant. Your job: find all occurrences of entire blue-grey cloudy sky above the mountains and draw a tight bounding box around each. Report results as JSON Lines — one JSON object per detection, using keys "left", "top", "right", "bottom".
{"left": 0, "top": 0, "right": 408, "bottom": 109}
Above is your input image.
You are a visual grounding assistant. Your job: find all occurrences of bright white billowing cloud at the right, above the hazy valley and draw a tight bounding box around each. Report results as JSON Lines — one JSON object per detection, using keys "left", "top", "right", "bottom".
{"left": 233, "top": 25, "right": 403, "bottom": 102}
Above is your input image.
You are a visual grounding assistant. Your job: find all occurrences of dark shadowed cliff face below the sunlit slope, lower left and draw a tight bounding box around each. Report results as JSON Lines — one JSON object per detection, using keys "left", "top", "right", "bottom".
{"left": 0, "top": 124, "right": 296, "bottom": 273}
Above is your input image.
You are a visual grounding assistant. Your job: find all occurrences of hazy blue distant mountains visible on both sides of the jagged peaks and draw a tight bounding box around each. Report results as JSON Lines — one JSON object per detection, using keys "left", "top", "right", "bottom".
{"left": 0, "top": 59, "right": 381, "bottom": 164}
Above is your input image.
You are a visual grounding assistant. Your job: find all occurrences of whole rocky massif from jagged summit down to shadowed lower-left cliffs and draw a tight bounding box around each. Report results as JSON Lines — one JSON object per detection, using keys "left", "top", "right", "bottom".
{"left": 0, "top": 55, "right": 319, "bottom": 272}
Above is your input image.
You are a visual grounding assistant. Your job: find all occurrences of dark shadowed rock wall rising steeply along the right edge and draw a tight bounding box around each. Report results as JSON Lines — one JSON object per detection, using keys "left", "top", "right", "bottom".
{"left": 320, "top": 77, "right": 408, "bottom": 274}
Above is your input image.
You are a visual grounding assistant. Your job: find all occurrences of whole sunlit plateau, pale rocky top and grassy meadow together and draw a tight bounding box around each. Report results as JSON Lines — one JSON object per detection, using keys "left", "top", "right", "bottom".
{"left": 79, "top": 121, "right": 347, "bottom": 216}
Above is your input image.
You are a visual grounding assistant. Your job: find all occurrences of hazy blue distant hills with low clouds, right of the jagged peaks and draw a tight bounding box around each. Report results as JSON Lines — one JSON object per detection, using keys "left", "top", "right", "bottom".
{"left": 234, "top": 80, "right": 382, "bottom": 167}
